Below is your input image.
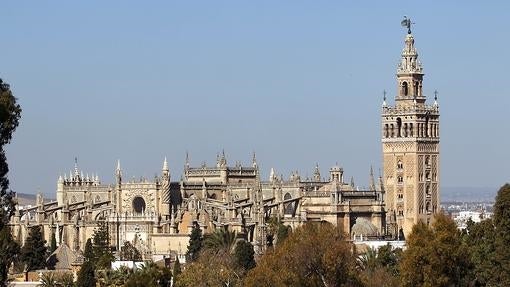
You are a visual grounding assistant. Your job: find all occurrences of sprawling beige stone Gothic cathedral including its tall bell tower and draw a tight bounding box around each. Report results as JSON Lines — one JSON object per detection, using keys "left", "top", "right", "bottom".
{"left": 7, "top": 23, "right": 439, "bottom": 264}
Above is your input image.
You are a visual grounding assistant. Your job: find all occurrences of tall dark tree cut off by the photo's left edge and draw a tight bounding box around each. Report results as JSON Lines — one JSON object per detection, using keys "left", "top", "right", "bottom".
{"left": 0, "top": 79, "right": 21, "bottom": 286}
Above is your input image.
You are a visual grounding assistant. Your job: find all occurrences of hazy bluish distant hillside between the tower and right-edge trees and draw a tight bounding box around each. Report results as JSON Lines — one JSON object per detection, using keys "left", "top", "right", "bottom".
{"left": 441, "top": 186, "right": 499, "bottom": 202}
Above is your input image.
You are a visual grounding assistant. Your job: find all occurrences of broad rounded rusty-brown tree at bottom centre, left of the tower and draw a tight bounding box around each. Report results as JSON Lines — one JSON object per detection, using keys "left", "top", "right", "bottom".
{"left": 244, "top": 222, "right": 361, "bottom": 286}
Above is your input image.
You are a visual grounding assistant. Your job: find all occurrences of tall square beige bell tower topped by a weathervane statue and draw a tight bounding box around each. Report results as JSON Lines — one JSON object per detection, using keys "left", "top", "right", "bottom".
{"left": 381, "top": 18, "right": 439, "bottom": 236}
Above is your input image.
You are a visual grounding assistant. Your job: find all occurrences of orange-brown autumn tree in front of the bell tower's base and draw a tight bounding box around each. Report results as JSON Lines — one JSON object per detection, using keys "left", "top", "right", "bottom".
{"left": 400, "top": 214, "right": 471, "bottom": 286}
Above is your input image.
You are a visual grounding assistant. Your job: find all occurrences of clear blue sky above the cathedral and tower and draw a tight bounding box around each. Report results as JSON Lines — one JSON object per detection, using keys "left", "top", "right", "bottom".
{"left": 0, "top": 1, "right": 510, "bottom": 198}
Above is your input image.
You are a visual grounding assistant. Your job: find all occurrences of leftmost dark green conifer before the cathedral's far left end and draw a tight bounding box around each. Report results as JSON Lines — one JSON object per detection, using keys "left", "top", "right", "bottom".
{"left": 21, "top": 225, "right": 47, "bottom": 271}
